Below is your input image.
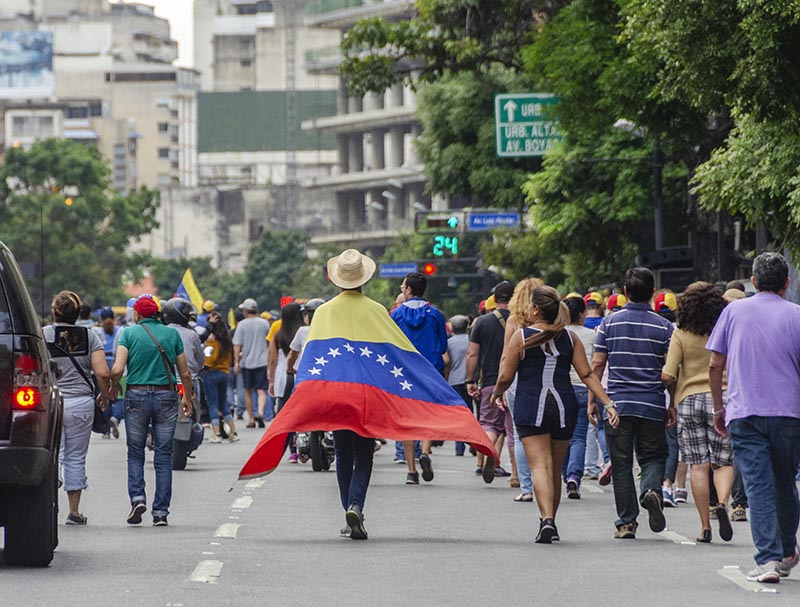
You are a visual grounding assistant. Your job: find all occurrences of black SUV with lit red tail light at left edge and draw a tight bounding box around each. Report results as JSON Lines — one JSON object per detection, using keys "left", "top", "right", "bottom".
{"left": 0, "top": 242, "right": 63, "bottom": 567}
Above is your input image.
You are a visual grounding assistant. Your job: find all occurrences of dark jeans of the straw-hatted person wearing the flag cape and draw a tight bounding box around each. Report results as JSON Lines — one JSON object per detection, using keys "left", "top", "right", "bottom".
{"left": 333, "top": 430, "right": 375, "bottom": 510}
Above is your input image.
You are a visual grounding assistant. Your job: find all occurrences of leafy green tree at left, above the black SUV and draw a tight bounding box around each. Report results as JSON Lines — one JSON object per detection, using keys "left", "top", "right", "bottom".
{"left": 0, "top": 139, "right": 159, "bottom": 310}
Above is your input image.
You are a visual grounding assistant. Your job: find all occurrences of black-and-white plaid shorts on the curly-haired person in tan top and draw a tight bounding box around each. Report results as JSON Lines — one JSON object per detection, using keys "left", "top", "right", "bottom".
{"left": 678, "top": 392, "right": 733, "bottom": 466}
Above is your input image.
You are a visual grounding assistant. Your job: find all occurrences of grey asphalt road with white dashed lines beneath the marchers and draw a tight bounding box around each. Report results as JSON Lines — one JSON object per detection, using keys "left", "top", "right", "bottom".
{"left": 0, "top": 430, "right": 800, "bottom": 607}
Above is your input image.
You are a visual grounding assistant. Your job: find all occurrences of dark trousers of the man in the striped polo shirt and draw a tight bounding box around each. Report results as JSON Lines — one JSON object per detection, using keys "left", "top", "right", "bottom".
{"left": 604, "top": 415, "right": 668, "bottom": 527}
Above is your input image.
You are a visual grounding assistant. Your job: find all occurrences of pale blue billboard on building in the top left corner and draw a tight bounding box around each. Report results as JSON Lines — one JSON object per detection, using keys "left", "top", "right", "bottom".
{"left": 0, "top": 31, "right": 54, "bottom": 99}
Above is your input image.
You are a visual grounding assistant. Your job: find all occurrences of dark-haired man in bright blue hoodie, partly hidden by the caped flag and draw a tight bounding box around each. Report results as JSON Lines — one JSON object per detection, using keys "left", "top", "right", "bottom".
{"left": 391, "top": 272, "right": 447, "bottom": 485}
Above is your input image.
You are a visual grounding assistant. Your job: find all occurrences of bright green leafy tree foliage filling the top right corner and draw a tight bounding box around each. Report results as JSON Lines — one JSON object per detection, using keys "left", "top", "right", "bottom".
{"left": 624, "top": 0, "right": 800, "bottom": 253}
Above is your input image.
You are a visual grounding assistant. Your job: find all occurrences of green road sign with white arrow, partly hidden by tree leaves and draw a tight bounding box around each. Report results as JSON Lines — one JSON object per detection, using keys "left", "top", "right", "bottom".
{"left": 494, "top": 93, "right": 561, "bottom": 158}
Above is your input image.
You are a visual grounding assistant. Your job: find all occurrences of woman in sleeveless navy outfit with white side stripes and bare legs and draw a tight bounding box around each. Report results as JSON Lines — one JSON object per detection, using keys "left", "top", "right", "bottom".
{"left": 492, "top": 286, "right": 619, "bottom": 544}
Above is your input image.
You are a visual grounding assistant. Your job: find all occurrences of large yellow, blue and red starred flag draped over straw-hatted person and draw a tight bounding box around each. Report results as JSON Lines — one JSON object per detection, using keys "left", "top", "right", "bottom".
{"left": 239, "top": 291, "right": 499, "bottom": 479}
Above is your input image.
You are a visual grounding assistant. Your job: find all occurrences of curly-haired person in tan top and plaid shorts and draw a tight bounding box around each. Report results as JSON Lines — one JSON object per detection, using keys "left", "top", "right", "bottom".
{"left": 661, "top": 282, "right": 733, "bottom": 544}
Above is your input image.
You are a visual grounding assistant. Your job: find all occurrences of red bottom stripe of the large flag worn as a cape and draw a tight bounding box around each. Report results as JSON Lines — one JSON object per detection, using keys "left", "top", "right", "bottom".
{"left": 239, "top": 380, "right": 500, "bottom": 479}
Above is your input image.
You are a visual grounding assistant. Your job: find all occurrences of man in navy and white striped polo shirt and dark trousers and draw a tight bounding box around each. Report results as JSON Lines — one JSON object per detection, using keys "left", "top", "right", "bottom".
{"left": 589, "top": 268, "right": 676, "bottom": 539}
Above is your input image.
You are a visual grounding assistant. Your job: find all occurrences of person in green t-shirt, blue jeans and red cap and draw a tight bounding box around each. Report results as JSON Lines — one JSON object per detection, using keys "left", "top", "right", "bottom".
{"left": 111, "top": 295, "right": 192, "bottom": 527}
